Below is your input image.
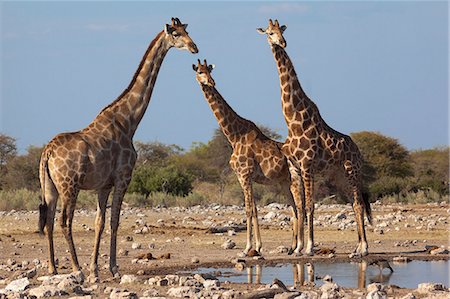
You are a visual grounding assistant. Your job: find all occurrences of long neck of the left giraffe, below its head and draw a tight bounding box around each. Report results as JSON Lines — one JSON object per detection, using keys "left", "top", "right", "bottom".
{"left": 88, "top": 31, "right": 170, "bottom": 138}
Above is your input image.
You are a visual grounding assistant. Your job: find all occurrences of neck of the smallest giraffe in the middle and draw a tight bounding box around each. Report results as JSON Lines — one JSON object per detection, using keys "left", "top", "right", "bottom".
{"left": 201, "top": 84, "right": 248, "bottom": 147}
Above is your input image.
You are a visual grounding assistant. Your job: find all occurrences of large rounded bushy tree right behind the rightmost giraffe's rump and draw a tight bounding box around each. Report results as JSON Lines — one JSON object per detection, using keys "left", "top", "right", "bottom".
{"left": 351, "top": 131, "right": 413, "bottom": 197}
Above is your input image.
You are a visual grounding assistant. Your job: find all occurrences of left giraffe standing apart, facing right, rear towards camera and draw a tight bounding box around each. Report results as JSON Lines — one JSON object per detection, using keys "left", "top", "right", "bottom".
{"left": 39, "top": 18, "right": 198, "bottom": 282}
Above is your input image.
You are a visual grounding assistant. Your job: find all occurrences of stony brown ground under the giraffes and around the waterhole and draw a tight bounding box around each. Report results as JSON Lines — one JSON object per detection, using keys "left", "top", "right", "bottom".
{"left": 0, "top": 203, "right": 450, "bottom": 298}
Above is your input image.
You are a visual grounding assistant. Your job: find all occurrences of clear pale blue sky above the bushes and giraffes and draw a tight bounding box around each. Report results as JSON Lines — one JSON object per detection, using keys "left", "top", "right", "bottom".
{"left": 0, "top": 1, "right": 449, "bottom": 152}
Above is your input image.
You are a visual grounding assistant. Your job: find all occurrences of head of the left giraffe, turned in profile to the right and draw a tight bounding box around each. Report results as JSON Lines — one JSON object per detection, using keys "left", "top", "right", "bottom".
{"left": 164, "top": 18, "right": 198, "bottom": 54}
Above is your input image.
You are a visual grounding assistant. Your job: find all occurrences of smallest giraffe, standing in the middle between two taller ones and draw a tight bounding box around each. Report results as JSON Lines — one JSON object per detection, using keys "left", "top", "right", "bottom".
{"left": 192, "top": 60, "right": 304, "bottom": 255}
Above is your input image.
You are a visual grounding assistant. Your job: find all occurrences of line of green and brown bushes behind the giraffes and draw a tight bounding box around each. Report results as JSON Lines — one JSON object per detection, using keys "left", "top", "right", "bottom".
{"left": 0, "top": 130, "right": 449, "bottom": 210}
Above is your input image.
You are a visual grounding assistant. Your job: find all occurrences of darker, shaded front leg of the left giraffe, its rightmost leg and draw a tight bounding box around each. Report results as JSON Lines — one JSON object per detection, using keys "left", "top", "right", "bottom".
{"left": 109, "top": 182, "right": 128, "bottom": 278}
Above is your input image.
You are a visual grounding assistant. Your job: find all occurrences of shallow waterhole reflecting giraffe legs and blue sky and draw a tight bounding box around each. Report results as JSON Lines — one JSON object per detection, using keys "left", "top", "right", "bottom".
{"left": 188, "top": 261, "right": 449, "bottom": 288}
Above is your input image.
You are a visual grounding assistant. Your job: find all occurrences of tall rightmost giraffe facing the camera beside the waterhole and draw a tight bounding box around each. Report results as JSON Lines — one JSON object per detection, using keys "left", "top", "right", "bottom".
{"left": 257, "top": 20, "right": 371, "bottom": 256}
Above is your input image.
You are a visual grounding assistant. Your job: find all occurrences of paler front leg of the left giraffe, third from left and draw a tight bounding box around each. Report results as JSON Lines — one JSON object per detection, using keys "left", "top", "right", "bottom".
{"left": 88, "top": 189, "right": 111, "bottom": 283}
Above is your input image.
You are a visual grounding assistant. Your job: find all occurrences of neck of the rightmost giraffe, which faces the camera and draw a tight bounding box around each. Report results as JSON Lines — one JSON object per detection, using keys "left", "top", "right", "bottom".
{"left": 271, "top": 45, "right": 317, "bottom": 127}
